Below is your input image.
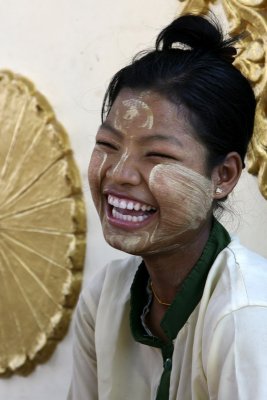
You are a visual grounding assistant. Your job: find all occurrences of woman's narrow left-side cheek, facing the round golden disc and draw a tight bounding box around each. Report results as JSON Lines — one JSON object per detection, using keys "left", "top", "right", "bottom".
{"left": 88, "top": 150, "right": 107, "bottom": 211}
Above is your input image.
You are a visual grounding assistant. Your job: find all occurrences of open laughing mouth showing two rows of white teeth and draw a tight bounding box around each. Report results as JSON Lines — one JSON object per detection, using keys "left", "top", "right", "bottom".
{"left": 107, "top": 195, "right": 156, "bottom": 223}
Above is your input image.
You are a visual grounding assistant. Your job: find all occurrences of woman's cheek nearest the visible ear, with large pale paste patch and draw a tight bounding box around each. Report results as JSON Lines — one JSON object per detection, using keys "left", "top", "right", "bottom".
{"left": 149, "top": 164, "right": 213, "bottom": 233}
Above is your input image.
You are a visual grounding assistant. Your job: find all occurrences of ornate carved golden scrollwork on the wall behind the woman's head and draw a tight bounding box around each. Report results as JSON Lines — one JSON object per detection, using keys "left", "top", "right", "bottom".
{"left": 179, "top": 0, "right": 267, "bottom": 199}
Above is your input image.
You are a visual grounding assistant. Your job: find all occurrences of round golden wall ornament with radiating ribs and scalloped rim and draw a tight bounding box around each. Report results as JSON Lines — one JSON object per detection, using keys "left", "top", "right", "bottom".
{"left": 0, "top": 71, "right": 86, "bottom": 376}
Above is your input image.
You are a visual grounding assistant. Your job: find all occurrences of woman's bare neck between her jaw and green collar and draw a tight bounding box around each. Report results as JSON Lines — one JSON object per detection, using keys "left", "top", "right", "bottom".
{"left": 143, "top": 220, "right": 214, "bottom": 309}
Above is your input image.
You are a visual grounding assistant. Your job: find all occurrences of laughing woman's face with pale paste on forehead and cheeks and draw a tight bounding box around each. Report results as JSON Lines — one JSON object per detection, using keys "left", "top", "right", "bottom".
{"left": 89, "top": 89, "right": 216, "bottom": 256}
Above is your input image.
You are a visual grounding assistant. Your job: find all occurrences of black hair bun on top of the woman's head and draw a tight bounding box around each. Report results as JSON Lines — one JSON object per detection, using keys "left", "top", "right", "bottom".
{"left": 156, "top": 14, "right": 239, "bottom": 63}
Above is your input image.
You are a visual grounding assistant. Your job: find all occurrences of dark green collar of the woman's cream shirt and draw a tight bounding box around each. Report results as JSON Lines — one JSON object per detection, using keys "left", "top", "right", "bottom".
{"left": 130, "top": 219, "right": 231, "bottom": 350}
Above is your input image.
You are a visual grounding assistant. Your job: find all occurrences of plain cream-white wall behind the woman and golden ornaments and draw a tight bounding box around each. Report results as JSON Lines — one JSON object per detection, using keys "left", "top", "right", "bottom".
{"left": 0, "top": 0, "right": 267, "bottom": 400}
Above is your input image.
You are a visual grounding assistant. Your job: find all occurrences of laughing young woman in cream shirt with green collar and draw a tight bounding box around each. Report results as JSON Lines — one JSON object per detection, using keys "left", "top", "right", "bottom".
{"left": 68, "top": 15, "right": 267, "bottom": 400}
